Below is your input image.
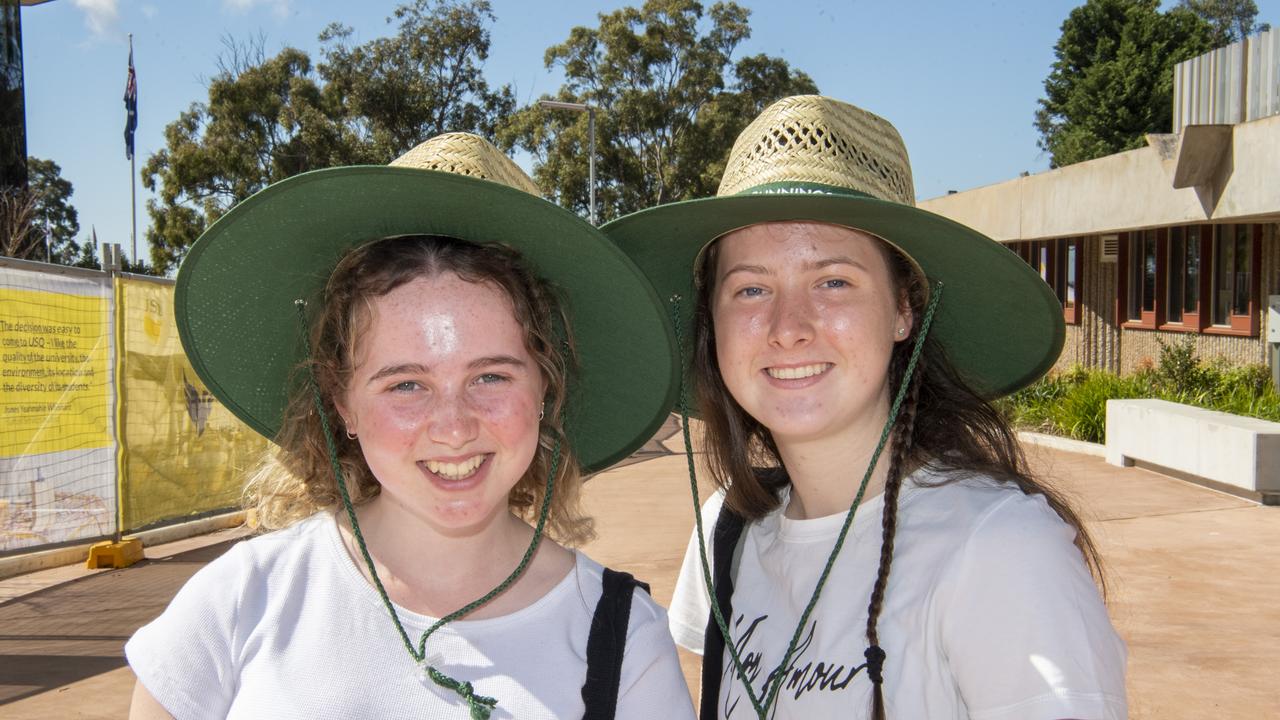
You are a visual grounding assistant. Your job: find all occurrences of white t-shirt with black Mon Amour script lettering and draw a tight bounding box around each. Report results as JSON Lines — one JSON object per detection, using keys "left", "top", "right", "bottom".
{"left": 669, "top": 471, "right": 1126, "bottom": 720}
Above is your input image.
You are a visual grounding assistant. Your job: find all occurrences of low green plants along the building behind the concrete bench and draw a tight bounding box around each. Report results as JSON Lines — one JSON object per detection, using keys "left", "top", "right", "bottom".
{"left": 996, "top": 337, "right": 1280, "bottom": 442}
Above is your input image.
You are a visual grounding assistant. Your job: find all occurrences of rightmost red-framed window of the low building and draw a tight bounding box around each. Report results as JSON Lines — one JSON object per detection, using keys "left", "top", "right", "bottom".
{"left": 1210, "top": 224, "right": 1261, "bottom": 334}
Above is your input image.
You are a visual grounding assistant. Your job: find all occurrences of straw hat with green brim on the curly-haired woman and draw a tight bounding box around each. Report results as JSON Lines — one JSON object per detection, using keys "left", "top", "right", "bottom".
{"left": 174, "top": 133, "right": 680, "bottom": 471}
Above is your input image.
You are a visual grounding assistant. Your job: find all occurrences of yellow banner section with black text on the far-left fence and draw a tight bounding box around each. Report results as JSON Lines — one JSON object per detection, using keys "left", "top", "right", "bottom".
{"left": 0, "top": 287, "right": 111, "bottom": 457}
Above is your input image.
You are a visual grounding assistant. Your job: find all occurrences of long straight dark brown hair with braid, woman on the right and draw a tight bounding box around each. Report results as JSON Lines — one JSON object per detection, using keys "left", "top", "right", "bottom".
{"left": 692, "top": 224, "right": 1106, "bottom": 720}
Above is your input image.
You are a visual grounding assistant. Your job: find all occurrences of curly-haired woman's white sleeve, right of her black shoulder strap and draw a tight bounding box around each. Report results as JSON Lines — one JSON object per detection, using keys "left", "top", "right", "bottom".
{"left": 614, "top": 588, "right": 695, "bottom": 720}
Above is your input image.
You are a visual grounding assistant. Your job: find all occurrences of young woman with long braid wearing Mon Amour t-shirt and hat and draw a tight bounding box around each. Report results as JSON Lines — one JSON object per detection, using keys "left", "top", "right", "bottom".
{"left": 604, "top": 96, "right": 1126, "bottom": 720}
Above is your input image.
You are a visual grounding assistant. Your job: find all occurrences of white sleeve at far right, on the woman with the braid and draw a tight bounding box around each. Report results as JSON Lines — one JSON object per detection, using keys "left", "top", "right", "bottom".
{"left": 941, "top": 493, "right": 1128, "bottom": 720}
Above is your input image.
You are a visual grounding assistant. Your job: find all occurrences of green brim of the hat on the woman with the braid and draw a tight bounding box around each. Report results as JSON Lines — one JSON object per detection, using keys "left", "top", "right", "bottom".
{"left": 602, "top": 188, "right": 1065, "bottom": 397}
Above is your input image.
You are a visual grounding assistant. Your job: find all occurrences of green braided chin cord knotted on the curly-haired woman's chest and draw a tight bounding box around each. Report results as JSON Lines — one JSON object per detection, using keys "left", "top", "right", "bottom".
{"left": 294, "top": 300, "right": 561, "bottom": 720}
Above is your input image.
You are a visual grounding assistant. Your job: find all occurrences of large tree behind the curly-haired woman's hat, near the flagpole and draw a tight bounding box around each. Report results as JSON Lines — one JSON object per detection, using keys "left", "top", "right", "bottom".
{"left": 142, "top": 0, "right": 515, "bottom": 273}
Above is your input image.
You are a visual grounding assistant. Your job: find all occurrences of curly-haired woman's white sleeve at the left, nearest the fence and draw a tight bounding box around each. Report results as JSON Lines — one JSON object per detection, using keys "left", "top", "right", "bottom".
{"left": 124, "top": 543, "right": 244, "bottom": 720}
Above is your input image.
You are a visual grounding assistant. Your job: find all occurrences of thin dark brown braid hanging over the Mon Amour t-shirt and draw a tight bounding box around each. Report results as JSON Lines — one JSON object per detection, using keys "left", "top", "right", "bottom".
{"left": 865, "top": 333, "right": 924, "bottom": 720}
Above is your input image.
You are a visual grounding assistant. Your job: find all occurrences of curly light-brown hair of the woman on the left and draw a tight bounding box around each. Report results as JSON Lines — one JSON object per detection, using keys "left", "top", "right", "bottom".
{"left": 246, "top": 236, "right": 593, "bottom": 544}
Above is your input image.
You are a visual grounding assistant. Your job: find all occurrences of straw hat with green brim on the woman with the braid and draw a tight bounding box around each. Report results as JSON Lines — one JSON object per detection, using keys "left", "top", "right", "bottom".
{"left": 602, "top": 95, "right": 1065, "bottom": 397}
